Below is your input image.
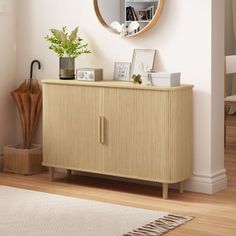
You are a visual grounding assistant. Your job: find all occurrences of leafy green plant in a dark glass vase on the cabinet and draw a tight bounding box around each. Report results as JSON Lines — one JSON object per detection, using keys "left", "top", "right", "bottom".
{"left": 45, "top": 26, "right": 91, "bottom": 79}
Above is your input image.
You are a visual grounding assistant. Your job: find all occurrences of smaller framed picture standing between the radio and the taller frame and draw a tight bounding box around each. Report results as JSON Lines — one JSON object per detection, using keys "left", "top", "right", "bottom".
{"left": 114, "top": 62, "right": 131, "bottom": 81}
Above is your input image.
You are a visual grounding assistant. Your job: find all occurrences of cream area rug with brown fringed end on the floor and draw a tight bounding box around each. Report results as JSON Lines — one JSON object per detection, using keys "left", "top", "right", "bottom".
{"left": 0, "top": 186, "right": 191, "bottom": 236}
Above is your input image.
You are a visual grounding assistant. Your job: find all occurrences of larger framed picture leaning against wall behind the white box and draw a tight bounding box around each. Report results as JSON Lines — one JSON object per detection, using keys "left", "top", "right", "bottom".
{"left": 131, "top": 49, "right": 156, "bottom": 76}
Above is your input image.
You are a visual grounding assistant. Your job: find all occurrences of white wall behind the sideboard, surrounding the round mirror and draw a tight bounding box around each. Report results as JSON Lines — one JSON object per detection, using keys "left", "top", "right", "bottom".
{"left": 17, "top": 0, "right": 224, "bottom": 193}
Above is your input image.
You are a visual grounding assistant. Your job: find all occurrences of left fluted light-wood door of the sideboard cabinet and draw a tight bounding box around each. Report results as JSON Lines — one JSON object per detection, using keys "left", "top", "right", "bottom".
{"left": 43, "top": 84, "right": 102, "bottom": 172}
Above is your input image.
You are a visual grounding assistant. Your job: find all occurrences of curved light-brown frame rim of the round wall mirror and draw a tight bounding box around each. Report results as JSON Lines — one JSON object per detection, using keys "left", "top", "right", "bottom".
{"left": 93, "top": 0, "right": 165, "bottom": 37}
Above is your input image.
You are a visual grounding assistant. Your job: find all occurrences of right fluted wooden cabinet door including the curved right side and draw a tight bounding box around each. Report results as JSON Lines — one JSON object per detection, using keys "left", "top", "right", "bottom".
{"left": 102, "top": 88, "right": 192, "bottom": 183}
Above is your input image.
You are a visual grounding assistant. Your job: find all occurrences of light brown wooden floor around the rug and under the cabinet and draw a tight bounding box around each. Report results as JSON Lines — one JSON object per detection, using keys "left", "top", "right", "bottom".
{"left": 0, "top": 119, "right": 236, "bottom": 236}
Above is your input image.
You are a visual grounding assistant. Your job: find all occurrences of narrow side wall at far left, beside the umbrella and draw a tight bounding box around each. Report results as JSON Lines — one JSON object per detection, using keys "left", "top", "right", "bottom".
{"left": 0, "top": 0, "right": 16, "bottom": 169}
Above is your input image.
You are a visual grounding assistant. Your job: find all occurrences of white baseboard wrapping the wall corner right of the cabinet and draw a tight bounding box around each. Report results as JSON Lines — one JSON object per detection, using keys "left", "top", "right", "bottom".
{"left": 185, "top": 169, "right": 228, "bottom": 194}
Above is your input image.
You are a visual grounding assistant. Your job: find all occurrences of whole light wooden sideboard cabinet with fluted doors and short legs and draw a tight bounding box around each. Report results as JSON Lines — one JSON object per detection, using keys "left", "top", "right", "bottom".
{"left": 43, "top": 80, "right": 193, "bottom": 198}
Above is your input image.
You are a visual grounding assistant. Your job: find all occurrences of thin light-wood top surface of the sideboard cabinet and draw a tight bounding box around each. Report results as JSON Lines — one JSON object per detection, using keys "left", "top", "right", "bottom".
{"left": 42, "top": 79, "right": 193, "bottom": 91}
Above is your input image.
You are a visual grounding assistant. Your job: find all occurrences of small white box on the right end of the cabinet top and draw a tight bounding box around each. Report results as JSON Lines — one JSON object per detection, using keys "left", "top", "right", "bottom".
{"left": 142, "top": 72, "right": 181, "bottom": 87}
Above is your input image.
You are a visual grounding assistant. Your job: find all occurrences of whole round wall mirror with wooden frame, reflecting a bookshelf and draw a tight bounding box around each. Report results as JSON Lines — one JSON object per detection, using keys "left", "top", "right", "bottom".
{"left": 94, "top": 0, "right": 164, "bottom": 37}
